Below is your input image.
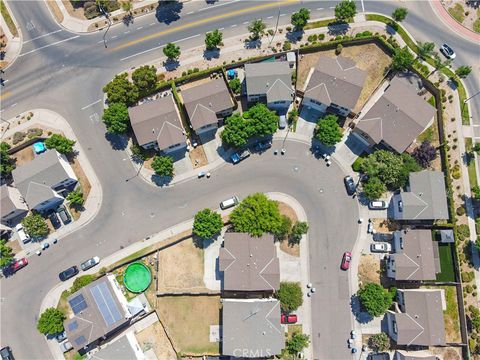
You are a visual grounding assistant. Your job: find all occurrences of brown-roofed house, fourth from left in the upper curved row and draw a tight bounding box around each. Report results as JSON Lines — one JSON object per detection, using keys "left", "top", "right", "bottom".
{"left": 302, "top": 56, "right": 367, "bottom": 116}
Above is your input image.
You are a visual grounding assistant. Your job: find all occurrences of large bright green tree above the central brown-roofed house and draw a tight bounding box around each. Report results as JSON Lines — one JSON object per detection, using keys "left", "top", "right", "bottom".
{"left": 230, "top": 193, "right": 282, "bottom": 236}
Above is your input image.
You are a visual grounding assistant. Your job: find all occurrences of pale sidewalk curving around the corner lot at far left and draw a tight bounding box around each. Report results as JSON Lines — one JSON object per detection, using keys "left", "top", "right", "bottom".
{"left": 4, "top": 109, "right": 102, "bottom": 258}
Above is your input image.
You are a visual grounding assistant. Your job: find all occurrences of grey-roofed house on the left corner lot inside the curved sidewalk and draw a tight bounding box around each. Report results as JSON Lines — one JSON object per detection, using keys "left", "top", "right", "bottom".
{"left": 12, "top": 150, "right": 78, "bottom": 212}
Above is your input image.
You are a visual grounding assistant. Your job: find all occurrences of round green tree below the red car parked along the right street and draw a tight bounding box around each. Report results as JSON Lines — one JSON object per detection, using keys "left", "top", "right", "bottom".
{"left": 357, "top": 283, "right": 396, "bottom": 317}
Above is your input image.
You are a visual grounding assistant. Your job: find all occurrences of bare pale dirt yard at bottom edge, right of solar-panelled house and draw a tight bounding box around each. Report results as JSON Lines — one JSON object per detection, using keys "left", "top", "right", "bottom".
{"left": 135, "top": 322, "right": 177, "bottom": 360}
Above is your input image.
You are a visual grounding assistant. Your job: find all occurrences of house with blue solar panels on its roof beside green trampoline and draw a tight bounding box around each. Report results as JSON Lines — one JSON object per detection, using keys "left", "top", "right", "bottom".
{"left": 64, "top": 275, "right": 142, "bottom": 351}
